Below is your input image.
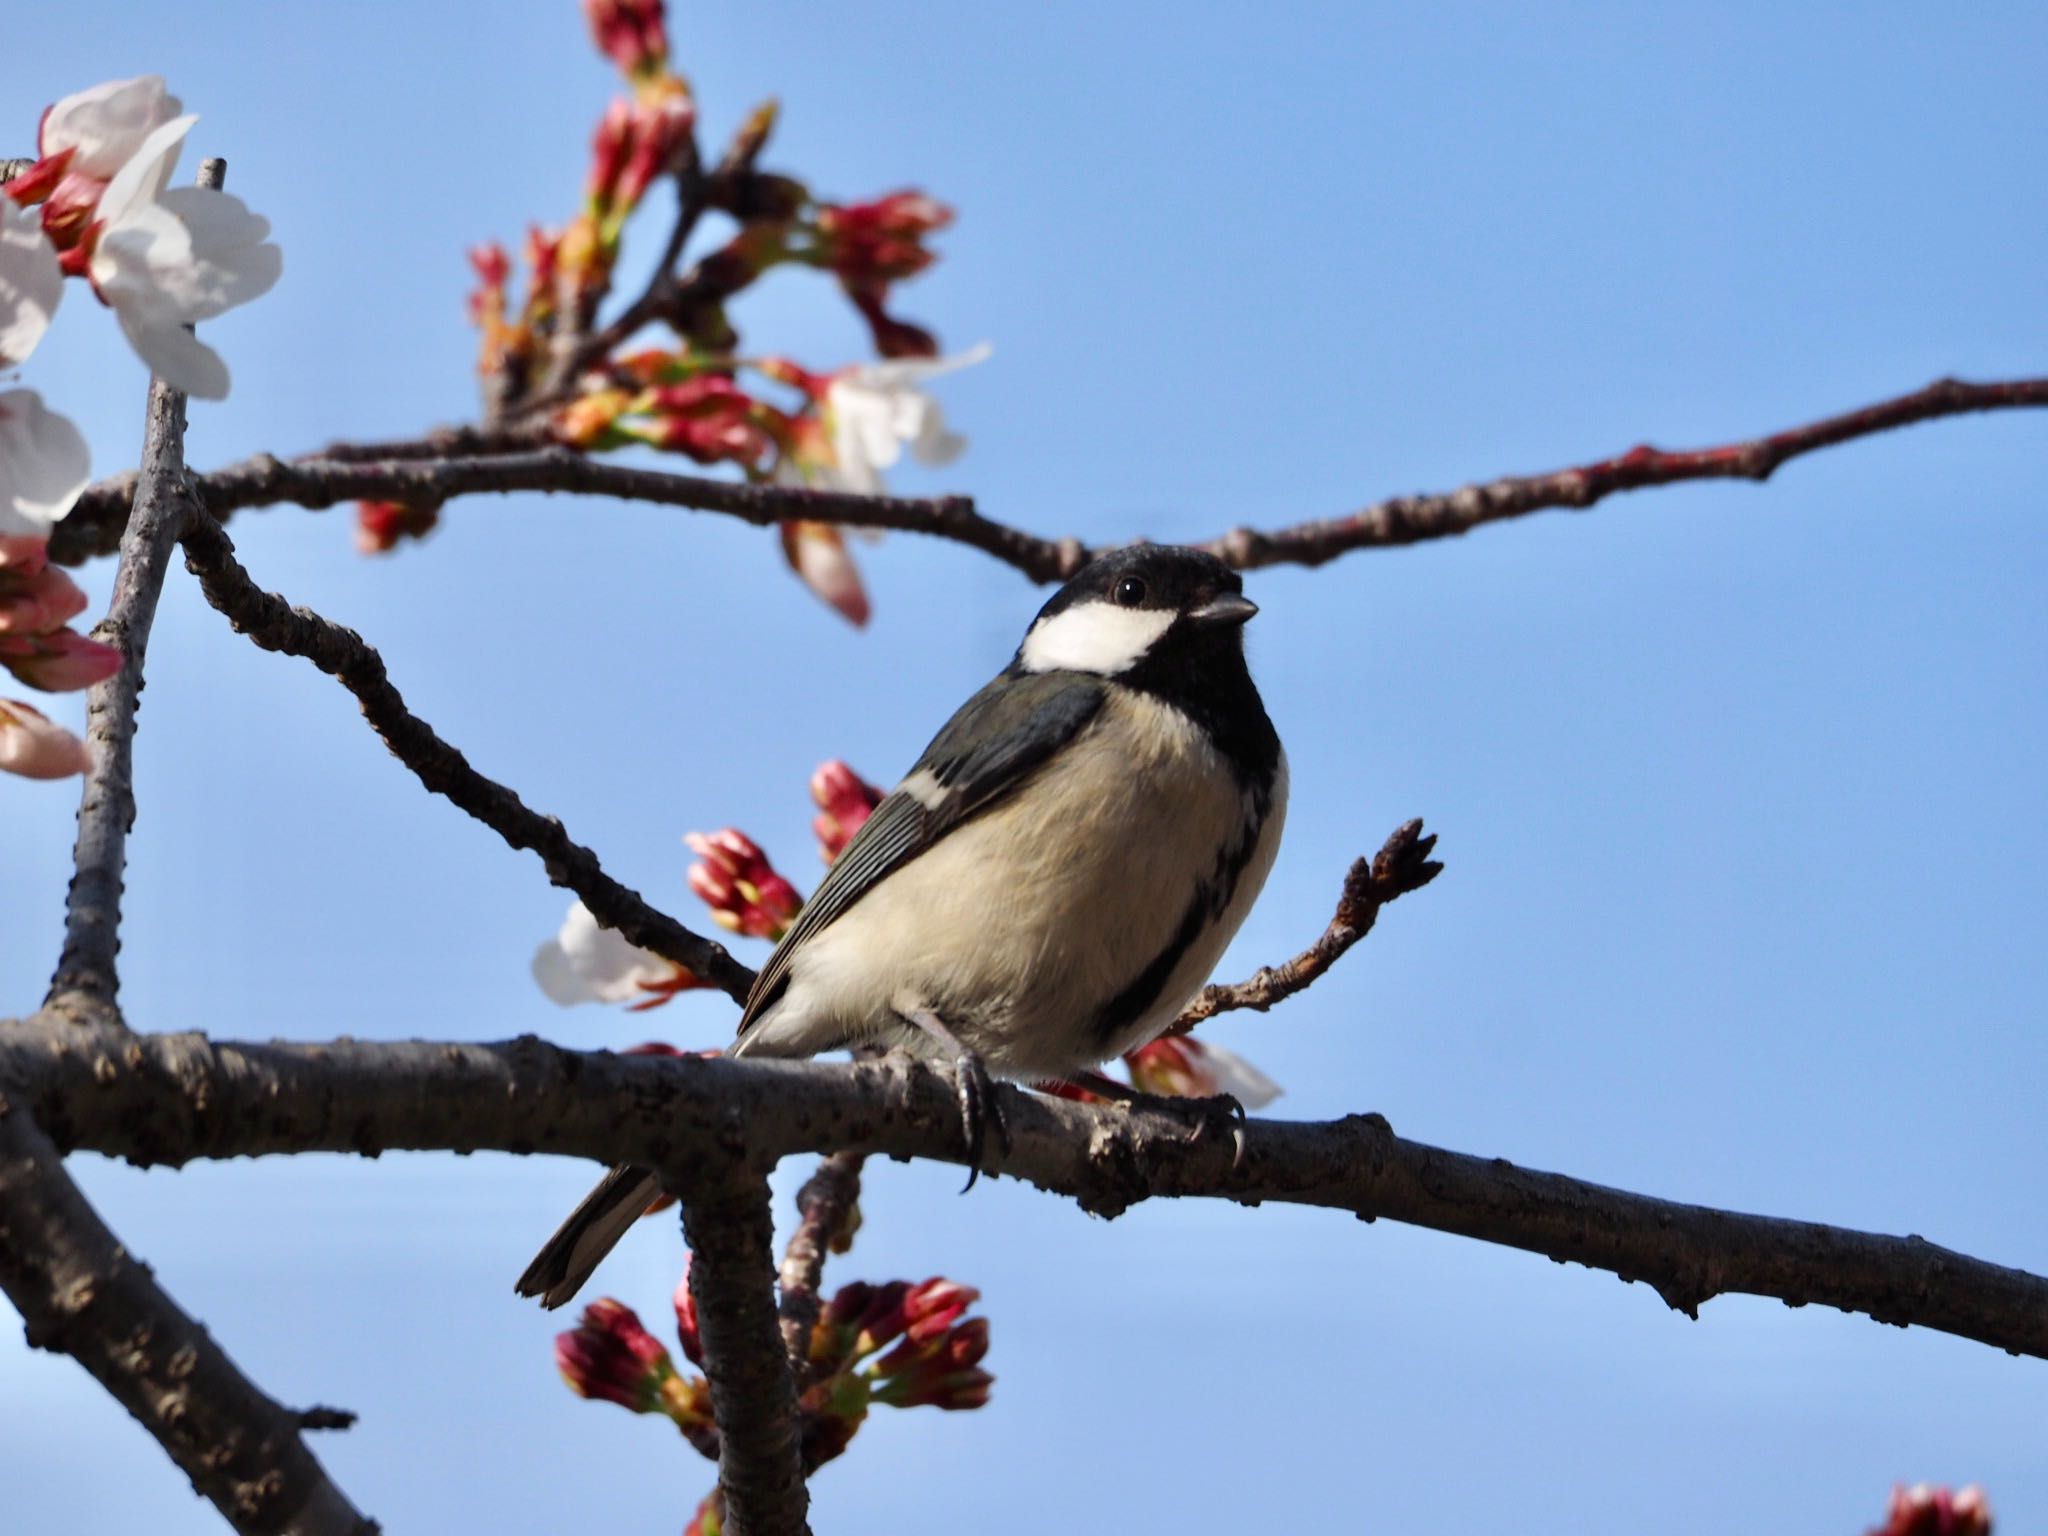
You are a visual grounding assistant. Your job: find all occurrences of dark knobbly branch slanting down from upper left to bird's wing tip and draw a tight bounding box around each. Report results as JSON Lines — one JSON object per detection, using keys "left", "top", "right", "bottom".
{"left": 184, "top": 516, "right": 754, "bottom": 999}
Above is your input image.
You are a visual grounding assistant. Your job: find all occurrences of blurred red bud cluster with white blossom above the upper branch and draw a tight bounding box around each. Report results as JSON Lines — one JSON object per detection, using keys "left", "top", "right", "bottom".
{"left": 446, "top": 0, "right": 983, "bottom": 625}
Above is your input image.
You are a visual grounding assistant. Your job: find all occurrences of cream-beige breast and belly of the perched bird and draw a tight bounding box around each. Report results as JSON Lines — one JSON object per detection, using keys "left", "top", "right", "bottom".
{"left": 745, "top": 688, "right": 1286, "bottom": 1079}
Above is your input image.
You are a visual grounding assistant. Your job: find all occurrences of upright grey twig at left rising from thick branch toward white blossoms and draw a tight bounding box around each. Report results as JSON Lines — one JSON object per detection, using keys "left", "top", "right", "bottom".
{"left": 49, "top": 160, "right": 227, "bottom": 1004}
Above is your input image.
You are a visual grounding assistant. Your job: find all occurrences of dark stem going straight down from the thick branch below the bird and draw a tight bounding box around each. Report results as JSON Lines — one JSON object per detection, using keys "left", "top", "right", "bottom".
{"left": 676, "top": 1157, "right": 811, "bottom": 1536}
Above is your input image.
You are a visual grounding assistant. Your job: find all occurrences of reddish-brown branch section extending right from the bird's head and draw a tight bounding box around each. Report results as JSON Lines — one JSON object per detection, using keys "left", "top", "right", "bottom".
{"left": 1204, "top": 379, "right": 2048, "bottom": 569}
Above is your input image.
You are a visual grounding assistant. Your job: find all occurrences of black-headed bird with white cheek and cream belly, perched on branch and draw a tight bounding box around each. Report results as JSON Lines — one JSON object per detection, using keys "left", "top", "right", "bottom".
{"left": 516, "top": 545, "right": 1288, "bottom": 1307}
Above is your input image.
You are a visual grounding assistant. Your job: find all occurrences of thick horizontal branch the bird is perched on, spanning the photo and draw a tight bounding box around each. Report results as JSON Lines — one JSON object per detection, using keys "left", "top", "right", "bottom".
{"left": 16, "top": 1022, "right": 2048, "bottom": 1358}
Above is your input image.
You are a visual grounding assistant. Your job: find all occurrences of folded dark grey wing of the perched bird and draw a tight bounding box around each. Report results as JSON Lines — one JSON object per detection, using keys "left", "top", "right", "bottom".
{"left": 739, "top": 672, "right": 1108, "bottom": 1034}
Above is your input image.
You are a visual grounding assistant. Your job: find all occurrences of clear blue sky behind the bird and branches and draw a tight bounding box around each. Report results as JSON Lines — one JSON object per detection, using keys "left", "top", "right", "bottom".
{"left": 0, "top": 0, "right": 2048, "bottom": 1536}
